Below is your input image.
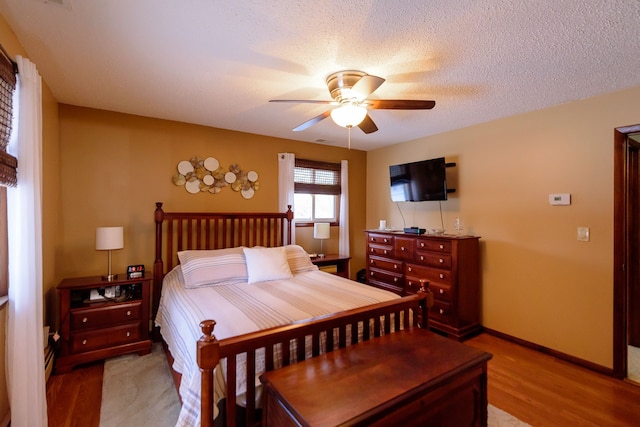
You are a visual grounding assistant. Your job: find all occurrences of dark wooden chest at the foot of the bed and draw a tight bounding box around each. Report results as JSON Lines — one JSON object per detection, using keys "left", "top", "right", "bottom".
{"left": 260, "top": 328, "right": 491, "bottom": 427}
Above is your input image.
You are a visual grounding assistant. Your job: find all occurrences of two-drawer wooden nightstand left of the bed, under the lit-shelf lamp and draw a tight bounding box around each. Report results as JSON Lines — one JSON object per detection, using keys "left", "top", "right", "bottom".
{"left": 56, "top": 273, "right": 153, "bottom": 373}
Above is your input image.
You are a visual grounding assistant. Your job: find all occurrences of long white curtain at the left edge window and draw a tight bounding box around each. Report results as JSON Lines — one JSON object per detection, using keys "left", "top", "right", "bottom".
{"left": 7, "top": 56, "right": 47, "bottom": 426}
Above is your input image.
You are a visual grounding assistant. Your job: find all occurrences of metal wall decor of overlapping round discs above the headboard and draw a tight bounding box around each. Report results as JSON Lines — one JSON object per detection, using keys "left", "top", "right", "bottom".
{"left": 173, "top": 157, "right": 260, "bottom": 199}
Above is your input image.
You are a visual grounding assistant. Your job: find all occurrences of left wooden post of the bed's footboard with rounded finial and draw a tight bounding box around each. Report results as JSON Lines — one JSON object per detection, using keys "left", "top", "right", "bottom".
{"left": 196, "top": 320, "right": 220, "bottom": 427}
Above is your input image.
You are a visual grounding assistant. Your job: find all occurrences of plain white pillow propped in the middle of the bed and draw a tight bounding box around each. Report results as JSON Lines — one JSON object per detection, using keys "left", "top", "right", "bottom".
{"left": 244, "top": 246, "right": 293, "bottom": 283}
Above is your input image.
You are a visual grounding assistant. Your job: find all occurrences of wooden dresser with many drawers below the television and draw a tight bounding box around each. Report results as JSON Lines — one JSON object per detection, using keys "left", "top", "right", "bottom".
{"left": 366, "top": 230, "right": 482, "bottom": 340}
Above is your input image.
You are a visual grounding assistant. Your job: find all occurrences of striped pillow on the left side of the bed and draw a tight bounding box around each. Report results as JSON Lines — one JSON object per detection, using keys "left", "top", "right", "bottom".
{"left": 178, "top": 247, "right": 249, "bottom": 289}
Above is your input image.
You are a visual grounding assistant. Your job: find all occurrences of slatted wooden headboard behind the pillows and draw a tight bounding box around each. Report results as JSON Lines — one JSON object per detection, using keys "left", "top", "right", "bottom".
{"left": 153, "top": 202, "right": 293, "bottom": 317}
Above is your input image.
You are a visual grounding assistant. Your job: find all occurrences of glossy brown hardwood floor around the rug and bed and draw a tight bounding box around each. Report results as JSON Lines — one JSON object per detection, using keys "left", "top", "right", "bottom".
{"left": 47, "top": 334, "right": 640, "bottom": 427}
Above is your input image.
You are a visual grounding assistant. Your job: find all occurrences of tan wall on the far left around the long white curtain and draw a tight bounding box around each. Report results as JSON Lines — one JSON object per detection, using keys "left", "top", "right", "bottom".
{"left": 0, "top": 12, "right": 61, "bottom": 420}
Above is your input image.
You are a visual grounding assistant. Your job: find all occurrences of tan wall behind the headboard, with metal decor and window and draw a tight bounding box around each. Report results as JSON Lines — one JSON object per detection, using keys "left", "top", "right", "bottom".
{"left": 56, "top": 105, "right": 366, "bottom": 284}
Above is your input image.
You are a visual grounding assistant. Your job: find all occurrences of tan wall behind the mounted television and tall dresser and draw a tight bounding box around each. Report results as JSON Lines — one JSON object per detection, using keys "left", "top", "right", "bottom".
{"left": 367, "top": 87, "right": 640, "bottom": 367}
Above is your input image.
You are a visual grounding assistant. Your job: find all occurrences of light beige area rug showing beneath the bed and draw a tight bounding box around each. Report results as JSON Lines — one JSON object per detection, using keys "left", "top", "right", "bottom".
{"left": 100, "top": 343, "right": 529, "bottom": 427}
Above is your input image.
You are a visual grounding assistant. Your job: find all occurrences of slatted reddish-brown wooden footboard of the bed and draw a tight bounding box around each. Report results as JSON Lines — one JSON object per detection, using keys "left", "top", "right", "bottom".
{"left": 197, "top": 288, "right": 433, "bottom": 426}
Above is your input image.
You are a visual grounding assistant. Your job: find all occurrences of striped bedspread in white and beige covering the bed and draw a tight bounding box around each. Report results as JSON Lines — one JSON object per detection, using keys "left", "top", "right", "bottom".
{"left": 155, "top": 267, "right": 398, "bottom": 426}
